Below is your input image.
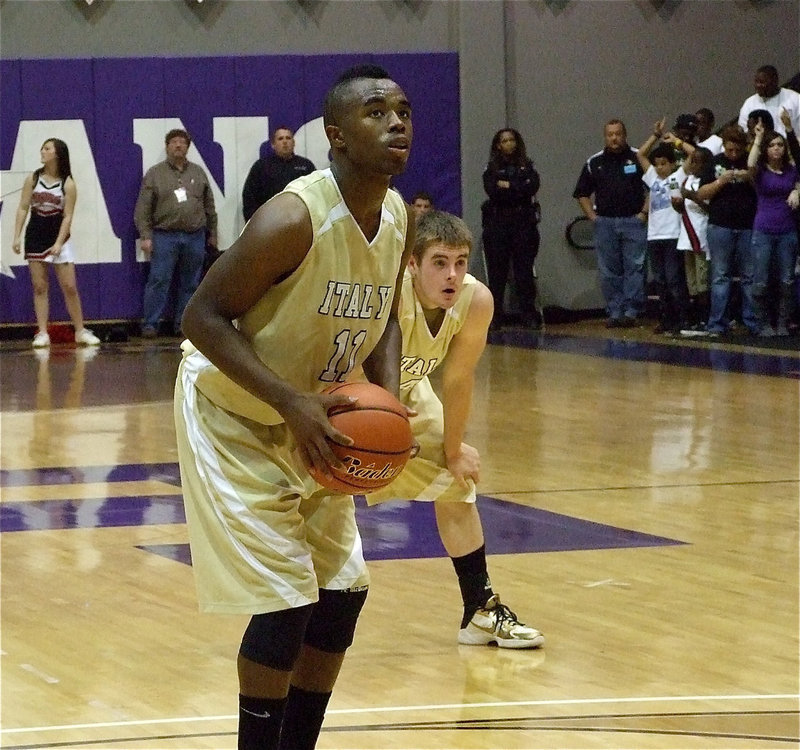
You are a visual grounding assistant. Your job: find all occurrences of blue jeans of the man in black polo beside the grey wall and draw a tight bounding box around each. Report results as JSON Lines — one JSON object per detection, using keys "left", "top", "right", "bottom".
{"left": 594, "top": 216, "right": 647, "bottom": 319}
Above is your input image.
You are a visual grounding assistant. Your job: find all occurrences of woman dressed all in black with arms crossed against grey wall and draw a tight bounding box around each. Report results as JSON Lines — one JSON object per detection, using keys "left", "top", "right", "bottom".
{"left": 482, "top": 128, "right": 542, "bottom": 329}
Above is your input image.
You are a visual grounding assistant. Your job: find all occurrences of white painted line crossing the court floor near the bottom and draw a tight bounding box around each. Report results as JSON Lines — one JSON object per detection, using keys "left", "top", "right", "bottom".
{"left": 0, "top": 693, "right": 800, "bottom": 734}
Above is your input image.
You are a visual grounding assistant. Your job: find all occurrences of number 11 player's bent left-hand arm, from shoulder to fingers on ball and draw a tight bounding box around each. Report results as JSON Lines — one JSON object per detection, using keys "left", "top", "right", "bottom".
{"left": 181, "top": 194, "right": 352, "bottom": 473}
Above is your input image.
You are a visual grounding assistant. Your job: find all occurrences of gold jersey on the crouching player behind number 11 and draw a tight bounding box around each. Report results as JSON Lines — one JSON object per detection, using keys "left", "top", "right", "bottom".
{"left": 400, "top": 271, "right": 476, "bottom": 393}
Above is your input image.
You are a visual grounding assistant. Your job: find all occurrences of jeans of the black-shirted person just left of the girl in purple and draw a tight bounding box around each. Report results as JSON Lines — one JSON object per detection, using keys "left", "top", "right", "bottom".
{"left": 706, "top": 224, "right": 761, "bottom": 333}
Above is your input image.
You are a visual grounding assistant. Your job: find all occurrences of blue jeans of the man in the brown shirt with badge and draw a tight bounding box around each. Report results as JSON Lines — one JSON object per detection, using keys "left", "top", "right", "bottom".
{"left": 143, "top": 229, "right": 206, "bottom": 332}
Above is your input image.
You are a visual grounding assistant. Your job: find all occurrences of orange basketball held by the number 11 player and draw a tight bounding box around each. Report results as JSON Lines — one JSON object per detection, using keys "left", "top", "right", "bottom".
{"left": 309, "top": 383, "right": 413, "bottom": 495}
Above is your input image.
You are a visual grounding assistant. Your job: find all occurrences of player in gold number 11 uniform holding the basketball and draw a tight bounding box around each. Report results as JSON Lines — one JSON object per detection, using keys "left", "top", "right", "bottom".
{"left": 175, "top": 65, "right": 413, "bottom": 750}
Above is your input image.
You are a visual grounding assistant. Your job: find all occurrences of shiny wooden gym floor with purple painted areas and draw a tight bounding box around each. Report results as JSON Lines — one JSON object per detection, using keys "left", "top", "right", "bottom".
{"left": 0, "top": 321, "right": 800, "bottom": 750}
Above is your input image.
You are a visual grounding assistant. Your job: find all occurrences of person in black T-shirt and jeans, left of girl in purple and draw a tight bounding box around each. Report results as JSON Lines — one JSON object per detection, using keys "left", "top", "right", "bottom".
{"left": 697, "top": 125, "right": 761, "bottom": 337}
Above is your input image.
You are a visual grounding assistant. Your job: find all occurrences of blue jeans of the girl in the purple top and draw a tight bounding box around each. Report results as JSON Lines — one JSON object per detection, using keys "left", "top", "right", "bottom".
{"left": 751, "top": 229, "right": 798, "bottom": 326}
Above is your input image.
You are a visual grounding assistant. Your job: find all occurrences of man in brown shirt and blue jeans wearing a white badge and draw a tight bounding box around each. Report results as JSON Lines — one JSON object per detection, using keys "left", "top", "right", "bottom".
{"left": 135, "top": 129, "right": 217, "bottom": 338}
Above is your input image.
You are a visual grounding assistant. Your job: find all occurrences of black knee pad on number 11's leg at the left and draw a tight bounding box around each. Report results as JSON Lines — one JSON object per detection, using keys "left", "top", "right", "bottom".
{"left": 239, "top": 604, "right": 315, "bottom": 672}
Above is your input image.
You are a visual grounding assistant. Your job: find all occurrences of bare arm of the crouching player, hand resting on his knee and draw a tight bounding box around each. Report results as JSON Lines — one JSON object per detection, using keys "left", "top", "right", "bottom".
{"left": 442, "top": 282, "right": 494, "bottom": 486}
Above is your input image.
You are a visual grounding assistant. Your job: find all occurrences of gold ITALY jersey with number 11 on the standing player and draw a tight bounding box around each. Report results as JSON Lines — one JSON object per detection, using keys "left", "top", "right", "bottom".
{"left": 184, "top": 169, "right": 408, "bottom": 424}
